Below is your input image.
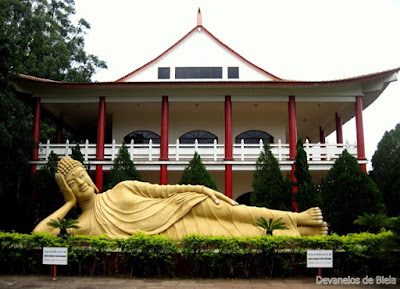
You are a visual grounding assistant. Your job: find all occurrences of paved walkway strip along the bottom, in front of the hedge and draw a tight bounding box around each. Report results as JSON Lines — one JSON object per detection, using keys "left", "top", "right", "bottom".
{"left": 0, "top": 275, "right": 400, "bottom": 289}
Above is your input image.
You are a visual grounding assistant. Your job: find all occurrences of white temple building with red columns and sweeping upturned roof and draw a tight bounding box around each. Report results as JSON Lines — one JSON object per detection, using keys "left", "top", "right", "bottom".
{"left": 15, "top": 10, "right": 400, "bottom": 199}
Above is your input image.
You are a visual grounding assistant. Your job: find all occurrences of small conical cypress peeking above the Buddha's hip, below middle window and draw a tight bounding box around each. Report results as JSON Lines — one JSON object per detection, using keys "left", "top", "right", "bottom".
{"left": 179, "top": 152, "right": 218, "bottom": 190}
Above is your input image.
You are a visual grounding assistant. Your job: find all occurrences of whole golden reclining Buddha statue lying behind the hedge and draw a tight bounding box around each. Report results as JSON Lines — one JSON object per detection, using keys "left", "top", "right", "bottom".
{"left": 34, "top": 158, "right": 328, "bottom": 239}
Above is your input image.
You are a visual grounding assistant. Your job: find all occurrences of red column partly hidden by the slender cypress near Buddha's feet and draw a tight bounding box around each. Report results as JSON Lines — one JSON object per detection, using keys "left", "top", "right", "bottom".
{"left": 288, "top": 95, "right": 298, "bottom": 212}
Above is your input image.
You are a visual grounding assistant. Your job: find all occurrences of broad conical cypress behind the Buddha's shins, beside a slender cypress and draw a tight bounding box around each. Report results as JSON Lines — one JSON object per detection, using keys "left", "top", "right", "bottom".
{"left": 250, "top": 141, "right": 292, "bottom": 210}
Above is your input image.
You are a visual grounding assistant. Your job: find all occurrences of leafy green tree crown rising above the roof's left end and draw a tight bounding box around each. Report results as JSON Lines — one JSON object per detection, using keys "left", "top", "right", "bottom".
{"left": 0, "top": 0, "right": 106, "bottom": 82}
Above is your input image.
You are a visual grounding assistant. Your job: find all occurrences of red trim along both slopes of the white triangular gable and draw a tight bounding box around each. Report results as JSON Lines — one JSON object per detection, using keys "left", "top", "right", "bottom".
{"left": 116, "top": 25, "right": 282, "bottom": 82}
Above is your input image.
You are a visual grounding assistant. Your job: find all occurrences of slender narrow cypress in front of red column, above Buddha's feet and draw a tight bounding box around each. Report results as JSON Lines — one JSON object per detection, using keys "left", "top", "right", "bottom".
{"left": 294, "top": 138, "right": 321, "bottom": 212}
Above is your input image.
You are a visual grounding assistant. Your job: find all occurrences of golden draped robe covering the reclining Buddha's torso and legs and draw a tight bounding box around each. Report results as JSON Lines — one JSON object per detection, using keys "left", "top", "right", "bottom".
{"left": 82, "top": 181, "right": 299, "bottom": 239}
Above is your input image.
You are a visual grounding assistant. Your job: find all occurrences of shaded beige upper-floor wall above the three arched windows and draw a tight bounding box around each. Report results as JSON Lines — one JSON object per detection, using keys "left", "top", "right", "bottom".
{"left": 112, "top": 102, "right": 287, "bottom": 143}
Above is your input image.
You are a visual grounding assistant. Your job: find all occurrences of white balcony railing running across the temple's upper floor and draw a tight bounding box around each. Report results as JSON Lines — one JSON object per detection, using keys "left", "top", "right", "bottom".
{"left": 39, "top": 140, "right": 357, "bottom": 163}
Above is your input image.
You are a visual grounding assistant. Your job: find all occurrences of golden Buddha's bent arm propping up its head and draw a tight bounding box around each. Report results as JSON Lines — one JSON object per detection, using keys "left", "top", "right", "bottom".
{"left": 33, "top": 174, "right": 76, "bottom": 234}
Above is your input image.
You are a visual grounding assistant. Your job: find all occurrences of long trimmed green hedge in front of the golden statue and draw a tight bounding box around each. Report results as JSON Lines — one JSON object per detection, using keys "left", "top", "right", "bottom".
{"left": 0, "top": 231, "right": 398, "bottom": 277}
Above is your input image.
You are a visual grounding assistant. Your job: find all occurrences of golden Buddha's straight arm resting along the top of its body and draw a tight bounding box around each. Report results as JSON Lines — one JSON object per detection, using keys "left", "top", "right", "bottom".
{"left": 126, "top": 181, "right": 238, "bottom": 206}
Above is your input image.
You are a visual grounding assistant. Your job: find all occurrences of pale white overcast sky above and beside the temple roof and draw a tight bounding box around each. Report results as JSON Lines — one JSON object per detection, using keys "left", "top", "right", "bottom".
{"left": 75, "top": 0, "right": 400, "bottom": 169}
